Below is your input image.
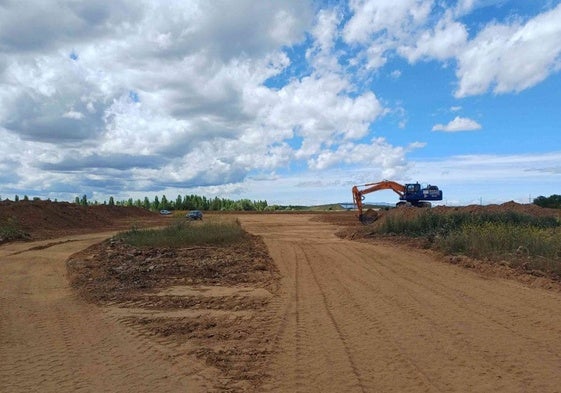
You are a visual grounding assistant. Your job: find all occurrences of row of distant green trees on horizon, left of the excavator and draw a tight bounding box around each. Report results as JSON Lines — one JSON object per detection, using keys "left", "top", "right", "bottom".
{"left": 74, "top": 195, "right": 270, "bottom": 211}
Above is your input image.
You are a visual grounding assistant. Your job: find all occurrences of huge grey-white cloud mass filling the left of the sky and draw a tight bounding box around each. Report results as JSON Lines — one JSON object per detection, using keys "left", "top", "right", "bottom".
{"left": 0, "top": 0, "right": 410, "bottom": 202}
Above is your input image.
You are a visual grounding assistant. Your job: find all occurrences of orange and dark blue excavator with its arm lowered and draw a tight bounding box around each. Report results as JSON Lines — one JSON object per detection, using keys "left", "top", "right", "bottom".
{"left": 353, "top": 180, "right": 442, "bottom": 223}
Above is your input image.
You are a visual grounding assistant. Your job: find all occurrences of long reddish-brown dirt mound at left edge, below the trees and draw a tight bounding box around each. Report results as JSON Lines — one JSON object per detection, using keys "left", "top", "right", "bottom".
{"left": 0, "top": 200, "right": 159, "bottom": 239}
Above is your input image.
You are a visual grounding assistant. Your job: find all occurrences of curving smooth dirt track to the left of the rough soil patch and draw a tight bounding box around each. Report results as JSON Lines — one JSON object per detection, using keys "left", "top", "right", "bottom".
{"left": 0, "top": 233, "right": 201, "bottom": 393}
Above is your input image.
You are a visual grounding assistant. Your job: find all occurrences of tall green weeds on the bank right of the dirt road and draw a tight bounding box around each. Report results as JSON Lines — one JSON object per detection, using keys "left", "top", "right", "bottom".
{"left": 377, "top": 212, "right": 561, "bottom": 277}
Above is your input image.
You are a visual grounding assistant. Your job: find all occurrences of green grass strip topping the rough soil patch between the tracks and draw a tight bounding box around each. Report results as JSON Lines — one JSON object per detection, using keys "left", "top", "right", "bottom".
{"left": 117, "top": 219, "right": 247, "bottom": 248}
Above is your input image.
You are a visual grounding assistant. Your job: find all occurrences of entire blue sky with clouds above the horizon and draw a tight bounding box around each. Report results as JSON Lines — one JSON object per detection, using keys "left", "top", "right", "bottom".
{"left": 0, "top": 0, "right": 561, "bottom": 204}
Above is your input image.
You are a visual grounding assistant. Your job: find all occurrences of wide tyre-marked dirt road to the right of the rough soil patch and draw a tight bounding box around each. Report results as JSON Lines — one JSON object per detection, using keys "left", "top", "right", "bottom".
{"left": 238, "top": 216, "right": 561, "bottom": 392}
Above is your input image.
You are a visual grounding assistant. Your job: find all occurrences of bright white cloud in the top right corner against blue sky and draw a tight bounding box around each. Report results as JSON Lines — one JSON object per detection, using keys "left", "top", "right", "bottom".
{"left": 455, "top": 4, "right": 561, "bottom": 97}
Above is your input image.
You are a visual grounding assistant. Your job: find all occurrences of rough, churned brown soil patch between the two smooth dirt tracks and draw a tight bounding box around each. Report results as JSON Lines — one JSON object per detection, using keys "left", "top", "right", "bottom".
{"left": 67, "top": 231, "right": 280, "bottom": 392}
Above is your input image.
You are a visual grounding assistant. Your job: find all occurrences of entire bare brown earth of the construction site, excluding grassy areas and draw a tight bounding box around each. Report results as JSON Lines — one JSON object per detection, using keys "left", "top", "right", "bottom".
{"left": 0, "top": 202, "right": 561, "bottom": 393}
